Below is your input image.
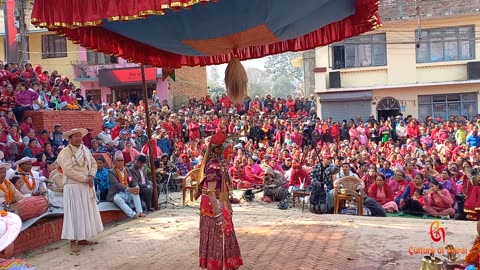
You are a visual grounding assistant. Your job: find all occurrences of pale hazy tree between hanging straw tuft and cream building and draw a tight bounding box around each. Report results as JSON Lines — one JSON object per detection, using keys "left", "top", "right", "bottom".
{"left": 265, "top": 52, "right": 304, "bottom": 96}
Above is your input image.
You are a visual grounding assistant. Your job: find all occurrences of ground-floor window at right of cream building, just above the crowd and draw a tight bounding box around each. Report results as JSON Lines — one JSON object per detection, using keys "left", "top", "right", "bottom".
{"left": 418, "top": 93, "right": 477, "bottom": 119}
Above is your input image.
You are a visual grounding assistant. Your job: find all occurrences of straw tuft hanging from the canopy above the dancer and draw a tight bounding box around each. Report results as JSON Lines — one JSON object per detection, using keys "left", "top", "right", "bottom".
{"left": 225, "top": 57, "right": 248, "bottom": 104}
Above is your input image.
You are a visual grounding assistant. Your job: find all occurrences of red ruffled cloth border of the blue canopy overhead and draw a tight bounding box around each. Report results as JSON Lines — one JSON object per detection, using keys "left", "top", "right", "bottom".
{"left": 32, "top": 0, "right": 381, "bottom": 68}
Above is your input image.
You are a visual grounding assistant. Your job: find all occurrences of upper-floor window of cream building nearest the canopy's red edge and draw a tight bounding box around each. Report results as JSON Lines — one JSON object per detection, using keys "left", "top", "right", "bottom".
{"left": 332, "top": 34, "right": 387, "bottom": 69}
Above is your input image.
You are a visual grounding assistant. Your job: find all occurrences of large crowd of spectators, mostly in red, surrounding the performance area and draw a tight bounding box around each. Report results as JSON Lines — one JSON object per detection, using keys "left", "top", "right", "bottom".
{"left": 0, "top": 60, "right": 480, "bottom": 219}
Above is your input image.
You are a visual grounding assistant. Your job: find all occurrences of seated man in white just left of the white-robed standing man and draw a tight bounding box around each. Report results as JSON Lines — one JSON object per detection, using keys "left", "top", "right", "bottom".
{"left": 15, "top": 157, "right": 46, "bottom": 196}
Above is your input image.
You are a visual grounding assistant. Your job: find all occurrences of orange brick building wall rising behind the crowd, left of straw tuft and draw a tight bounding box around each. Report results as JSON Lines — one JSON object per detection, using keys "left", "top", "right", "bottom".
{"left": 168, "top": 67, "right": 207, "bottom": 101}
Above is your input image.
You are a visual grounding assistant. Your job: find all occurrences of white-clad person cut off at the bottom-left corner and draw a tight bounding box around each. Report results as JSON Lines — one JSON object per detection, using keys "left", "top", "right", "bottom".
{"left": 0, "top": 211, "right": 36, "bottom": 270}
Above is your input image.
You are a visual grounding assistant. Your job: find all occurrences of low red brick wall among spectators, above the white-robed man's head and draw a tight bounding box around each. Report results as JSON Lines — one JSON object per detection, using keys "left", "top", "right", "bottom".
{"left": 25, "top": 111, "right": 103, "bottom": 136}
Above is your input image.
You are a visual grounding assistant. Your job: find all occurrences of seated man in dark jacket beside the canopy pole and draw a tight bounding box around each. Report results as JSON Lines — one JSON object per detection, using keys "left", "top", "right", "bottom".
{"left": 128, "top": 155, "right": 154, "bottom": 212}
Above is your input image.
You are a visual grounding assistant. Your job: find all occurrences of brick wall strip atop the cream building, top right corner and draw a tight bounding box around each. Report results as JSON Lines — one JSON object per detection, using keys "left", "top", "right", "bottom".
{"left": 380, "top": 0, "right": 480, "bottom": 21}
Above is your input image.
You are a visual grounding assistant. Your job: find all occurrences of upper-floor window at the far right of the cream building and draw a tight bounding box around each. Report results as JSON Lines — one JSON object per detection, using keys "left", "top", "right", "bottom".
{"left": 416, "top": 26, "right": 475, "bottom": 63}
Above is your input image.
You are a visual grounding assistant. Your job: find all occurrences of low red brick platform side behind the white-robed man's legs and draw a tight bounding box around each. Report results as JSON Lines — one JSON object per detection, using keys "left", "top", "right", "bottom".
{"left": 13, "top": 211, "right": 127, "bottom": 255}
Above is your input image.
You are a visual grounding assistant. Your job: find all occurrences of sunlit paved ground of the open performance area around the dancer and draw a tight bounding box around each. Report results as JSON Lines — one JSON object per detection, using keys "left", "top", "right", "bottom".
{"left": 26, "top": 191, "right": 475, "bottom": 270}
